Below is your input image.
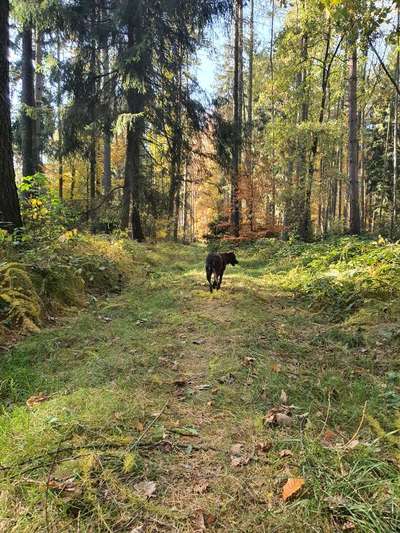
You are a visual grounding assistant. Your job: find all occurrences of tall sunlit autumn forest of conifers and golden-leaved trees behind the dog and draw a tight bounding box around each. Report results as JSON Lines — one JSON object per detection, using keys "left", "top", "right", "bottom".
{"left": 0, "top": 0, "right": 400, "bottom": 242}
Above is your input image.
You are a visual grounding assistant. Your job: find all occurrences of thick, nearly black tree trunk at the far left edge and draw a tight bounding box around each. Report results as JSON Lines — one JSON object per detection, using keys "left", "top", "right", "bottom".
{"left": 0, "top": 0, "right": 22, "bottom": 229}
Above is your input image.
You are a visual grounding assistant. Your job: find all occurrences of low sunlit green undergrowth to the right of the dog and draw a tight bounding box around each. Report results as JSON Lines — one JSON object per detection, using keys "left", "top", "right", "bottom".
{"left": 233, "top": 237, "right": 400, "bottom": 319}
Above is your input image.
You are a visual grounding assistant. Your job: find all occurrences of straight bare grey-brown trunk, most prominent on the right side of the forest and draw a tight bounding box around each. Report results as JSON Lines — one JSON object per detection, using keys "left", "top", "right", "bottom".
{"left": 349, "top": 34, "right": 361, "bottom": 235}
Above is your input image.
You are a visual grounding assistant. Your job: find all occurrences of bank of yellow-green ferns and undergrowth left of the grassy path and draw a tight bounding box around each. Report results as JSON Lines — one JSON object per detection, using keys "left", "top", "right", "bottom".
{"left": 0, "top": 231, "right": 144, "bottom": 339}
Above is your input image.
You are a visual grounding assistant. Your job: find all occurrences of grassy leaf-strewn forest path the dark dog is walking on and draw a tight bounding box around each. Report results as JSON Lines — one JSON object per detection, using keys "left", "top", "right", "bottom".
{"left": 0, "top": 245, "right": 400, "bottom": 533}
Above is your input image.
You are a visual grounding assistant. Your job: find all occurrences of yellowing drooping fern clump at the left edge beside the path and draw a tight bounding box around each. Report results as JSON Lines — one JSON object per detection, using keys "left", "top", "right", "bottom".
{"left": 0, "top": 263, "right": 42, "bottom": 332}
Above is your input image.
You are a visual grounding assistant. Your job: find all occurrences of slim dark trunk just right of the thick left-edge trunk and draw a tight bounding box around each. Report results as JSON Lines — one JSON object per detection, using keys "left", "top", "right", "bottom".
{"left": 21, "top": 22, "right": 37, "bottom": 176}
